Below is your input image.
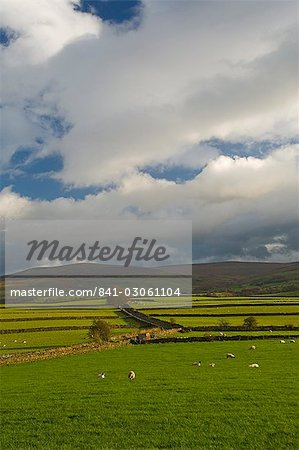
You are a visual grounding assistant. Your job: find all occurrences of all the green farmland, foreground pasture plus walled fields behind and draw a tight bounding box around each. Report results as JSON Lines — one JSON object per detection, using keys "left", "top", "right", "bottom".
{"left": 0, "top": 286, "right": 299, "bottom": 450}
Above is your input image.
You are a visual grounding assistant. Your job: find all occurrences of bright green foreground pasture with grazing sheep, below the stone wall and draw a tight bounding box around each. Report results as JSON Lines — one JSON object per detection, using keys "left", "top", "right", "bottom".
{"left": 0, "top": 340, "right": 298, "bottom": 450}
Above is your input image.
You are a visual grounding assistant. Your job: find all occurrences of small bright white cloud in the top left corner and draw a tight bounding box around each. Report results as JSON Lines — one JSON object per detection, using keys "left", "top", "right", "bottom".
{"left": 0, "top": 0, "right": 100, "bottom": 66}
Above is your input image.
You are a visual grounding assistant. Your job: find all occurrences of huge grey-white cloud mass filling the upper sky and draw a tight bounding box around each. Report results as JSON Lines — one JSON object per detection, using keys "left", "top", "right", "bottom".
{"left": 2, "top": 0, "right": 298, "bottom": 186}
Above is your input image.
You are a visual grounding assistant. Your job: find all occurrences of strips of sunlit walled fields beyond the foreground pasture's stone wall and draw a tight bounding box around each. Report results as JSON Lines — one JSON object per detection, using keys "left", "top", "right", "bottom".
{"left": 0, "top": 296, "right": 299, "bottom": 354}
